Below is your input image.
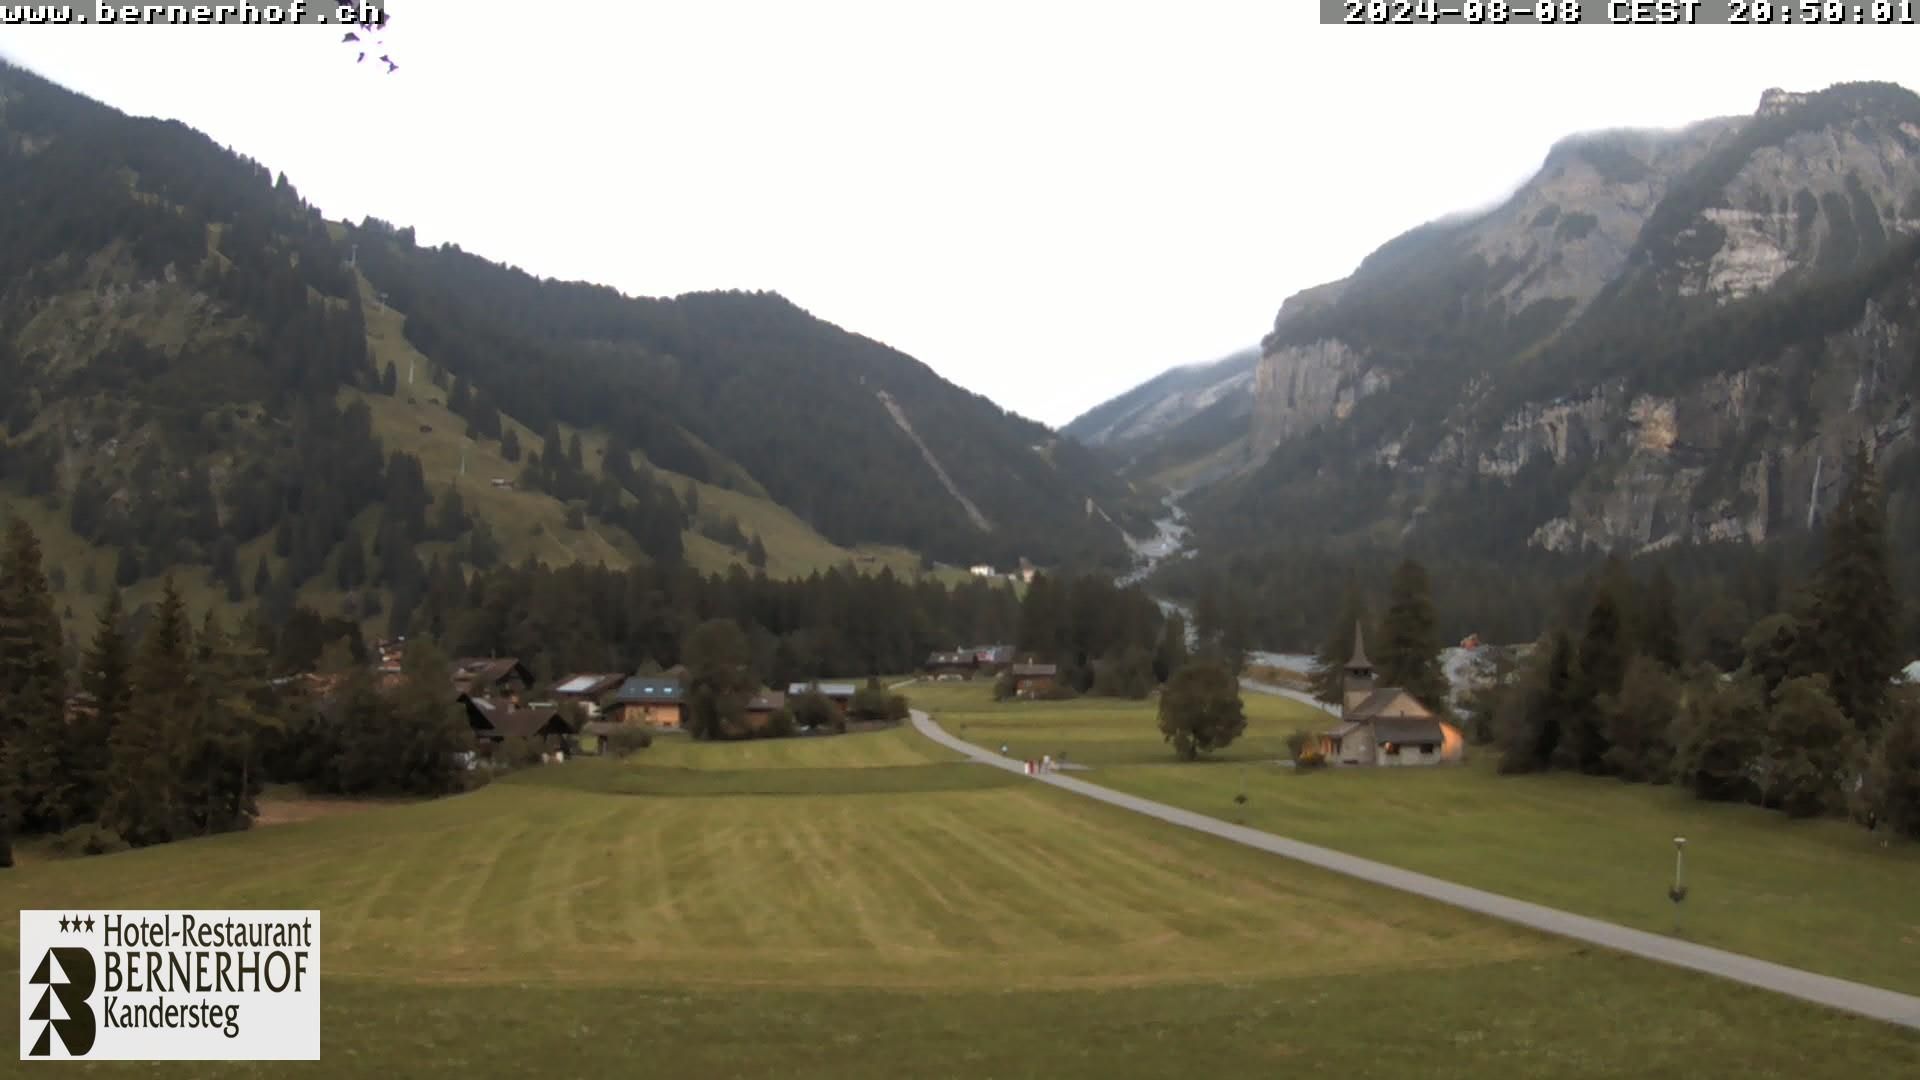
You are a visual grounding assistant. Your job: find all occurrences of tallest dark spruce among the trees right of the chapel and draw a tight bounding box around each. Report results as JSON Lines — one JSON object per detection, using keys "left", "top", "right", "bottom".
{"left": 1811, "top": 444, "right": 1901, "bottom": 734}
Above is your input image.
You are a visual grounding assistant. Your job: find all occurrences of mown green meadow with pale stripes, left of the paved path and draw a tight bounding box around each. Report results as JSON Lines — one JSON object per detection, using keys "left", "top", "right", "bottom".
{"left": 0, "top": 711, "right": 1920, "bottom": 1078}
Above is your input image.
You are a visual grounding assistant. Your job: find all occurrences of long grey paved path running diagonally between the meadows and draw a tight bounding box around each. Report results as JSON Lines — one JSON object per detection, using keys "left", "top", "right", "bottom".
{"left": 914, "top": 709, "right": 1920, "bottom": 1030}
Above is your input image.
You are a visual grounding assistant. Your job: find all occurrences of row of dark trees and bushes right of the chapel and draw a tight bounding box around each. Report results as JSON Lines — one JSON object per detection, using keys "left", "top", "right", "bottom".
{"left": 1469, "top": 446, "right": 1920, "bottom": 836}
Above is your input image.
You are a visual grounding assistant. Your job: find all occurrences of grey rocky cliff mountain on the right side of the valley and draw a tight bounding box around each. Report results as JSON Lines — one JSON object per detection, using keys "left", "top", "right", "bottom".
{"left": 1090, "top": 85, "right": 1920, "bottom": 550}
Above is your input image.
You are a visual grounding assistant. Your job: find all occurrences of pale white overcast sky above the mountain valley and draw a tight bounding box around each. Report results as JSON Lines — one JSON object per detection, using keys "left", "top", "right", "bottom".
{"left": 0, "top": 0, "right": 1920, "bottom": 425}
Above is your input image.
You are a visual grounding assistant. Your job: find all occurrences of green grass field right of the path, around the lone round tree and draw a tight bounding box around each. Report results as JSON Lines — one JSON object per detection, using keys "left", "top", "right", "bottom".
{"left": 910, "top": 684, "right": 1920, "bottom": 994}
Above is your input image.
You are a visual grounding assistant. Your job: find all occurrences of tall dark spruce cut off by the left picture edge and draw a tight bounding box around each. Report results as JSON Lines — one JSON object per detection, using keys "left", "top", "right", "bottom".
{"left": 0, "top": 517, "right": 77, "bottom": 830}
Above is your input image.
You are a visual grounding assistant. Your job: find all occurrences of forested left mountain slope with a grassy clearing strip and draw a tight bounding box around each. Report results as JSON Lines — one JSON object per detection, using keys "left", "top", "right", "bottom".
{"left": 0, "top": 65, "right": 1127, "bottom": 638}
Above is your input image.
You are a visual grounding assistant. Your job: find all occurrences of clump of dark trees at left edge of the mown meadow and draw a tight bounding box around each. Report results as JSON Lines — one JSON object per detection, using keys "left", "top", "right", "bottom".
{"left": 0, "top": 519, "right": 470, "bottom": 865}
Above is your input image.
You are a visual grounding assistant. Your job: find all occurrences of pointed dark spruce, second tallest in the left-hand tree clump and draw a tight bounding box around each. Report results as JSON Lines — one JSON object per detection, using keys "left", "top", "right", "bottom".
{"left": 100, "top": 575, "right": 200, "bottom": 846}
